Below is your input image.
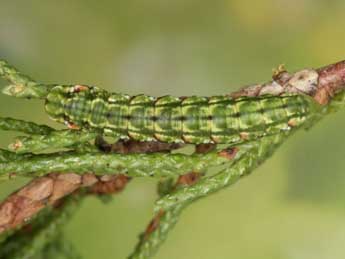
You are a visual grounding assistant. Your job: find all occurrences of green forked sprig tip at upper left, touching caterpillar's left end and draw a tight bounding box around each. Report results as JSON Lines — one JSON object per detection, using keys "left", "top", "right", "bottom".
{"left": 0, "top": 60, "right": 51, "bottom": 99}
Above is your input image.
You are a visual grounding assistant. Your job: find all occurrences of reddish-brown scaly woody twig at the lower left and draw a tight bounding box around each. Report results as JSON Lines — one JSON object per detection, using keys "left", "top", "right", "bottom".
{"left": 0, "top": 173, "right": 129, "bottom": 234}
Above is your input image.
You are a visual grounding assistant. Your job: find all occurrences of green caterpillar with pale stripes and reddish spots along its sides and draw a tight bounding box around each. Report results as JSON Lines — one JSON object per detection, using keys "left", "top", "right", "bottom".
{"left": 45, "top": 85, "right": 316, "bottom": 144}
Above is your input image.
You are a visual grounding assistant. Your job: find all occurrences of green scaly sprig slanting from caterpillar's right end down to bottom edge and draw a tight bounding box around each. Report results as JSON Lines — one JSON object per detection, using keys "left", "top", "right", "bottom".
{"left": 129, "top": 134, "right": 287, "bottom": 259}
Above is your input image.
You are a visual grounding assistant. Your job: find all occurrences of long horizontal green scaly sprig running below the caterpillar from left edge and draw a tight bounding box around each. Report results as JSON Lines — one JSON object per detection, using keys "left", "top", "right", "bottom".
{"left": 0, "top": 148, "right": 238, "bottom": 177}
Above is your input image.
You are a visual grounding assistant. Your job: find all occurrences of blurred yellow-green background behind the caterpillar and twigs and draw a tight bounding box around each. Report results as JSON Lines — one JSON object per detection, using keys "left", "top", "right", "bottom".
{"left": 0, "top": 0, "right": 345, "bottom": 259}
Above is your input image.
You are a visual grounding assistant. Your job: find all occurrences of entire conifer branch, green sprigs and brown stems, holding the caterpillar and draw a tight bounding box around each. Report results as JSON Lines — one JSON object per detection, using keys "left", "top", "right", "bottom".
{"left": 0, "top": 61, "right": 345, "bottom": 259}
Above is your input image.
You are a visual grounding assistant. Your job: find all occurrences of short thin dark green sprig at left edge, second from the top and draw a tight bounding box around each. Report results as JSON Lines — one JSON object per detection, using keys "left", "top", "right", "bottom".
{"left": 0, "top": 117, "right": 54, "bottom": 135}
